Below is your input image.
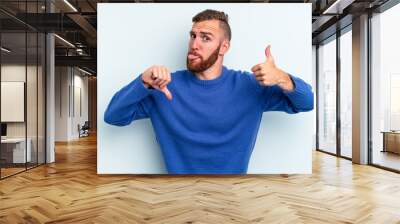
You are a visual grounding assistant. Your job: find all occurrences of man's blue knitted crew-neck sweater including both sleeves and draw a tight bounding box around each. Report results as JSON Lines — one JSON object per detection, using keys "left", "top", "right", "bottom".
{"left": 104, "top": 66, "right": 314, "bottom": 174}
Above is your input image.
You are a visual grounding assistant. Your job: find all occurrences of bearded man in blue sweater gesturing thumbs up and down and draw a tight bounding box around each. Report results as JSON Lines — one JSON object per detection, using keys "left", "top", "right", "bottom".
{"left": 104, "top": 10, "right": 313, "bottom": 174}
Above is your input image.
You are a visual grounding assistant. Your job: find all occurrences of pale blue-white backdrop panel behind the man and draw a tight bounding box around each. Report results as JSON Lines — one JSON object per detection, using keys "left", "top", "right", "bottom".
{"left": 97, "top": 3, "right": 315, "bottom": 174}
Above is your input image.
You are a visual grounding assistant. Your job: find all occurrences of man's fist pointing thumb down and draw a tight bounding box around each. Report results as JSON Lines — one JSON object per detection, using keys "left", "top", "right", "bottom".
{"left": 142, "top": 65, "right": 172, "bottom": 100}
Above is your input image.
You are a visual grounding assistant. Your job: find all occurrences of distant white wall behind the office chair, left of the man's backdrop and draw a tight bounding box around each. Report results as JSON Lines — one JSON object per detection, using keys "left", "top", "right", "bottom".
{"left": 55, "top": 67, "right": 88, "bottom": 141}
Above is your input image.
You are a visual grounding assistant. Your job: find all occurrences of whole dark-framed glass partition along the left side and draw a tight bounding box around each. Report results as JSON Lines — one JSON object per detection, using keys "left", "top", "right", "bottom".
{"left": 0, "top": 1, "right": 46, "bottom": 179}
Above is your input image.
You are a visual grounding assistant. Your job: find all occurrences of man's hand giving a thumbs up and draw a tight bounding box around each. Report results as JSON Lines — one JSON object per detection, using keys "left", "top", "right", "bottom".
{"left": 251, "top": 45, "right": 294, "bottom": 91}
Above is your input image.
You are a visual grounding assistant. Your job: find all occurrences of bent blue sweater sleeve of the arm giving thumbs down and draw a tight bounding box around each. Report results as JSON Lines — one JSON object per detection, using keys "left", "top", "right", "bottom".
{"left": 104, "top": 74, "right": 155, "bottom": 126}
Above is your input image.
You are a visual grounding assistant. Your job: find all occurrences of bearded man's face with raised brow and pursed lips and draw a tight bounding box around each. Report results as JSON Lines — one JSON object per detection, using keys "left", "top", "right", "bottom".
{"left": 186, "top": 20, "right": 224, "bottom": 72}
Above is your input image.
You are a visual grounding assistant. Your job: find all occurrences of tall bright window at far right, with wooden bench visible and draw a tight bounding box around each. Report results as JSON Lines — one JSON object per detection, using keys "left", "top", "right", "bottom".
{"left": 370, "top": 4, "right": 400, "bottom": 170}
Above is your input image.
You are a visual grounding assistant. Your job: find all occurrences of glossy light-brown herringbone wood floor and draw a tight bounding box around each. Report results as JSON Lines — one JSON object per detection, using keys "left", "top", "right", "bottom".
{"left": 0, "top": 134, "right": 400, "bottom": 224}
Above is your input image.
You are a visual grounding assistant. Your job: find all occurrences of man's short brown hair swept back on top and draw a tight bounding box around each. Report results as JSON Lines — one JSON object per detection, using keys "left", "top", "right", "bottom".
{"left": 192, "top": 9, "right": 232, "bottom": 40}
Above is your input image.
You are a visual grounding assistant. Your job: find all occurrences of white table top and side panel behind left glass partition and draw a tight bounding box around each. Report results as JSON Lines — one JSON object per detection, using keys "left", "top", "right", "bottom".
{"left": 1, "top": 138, "right": 32, "bottom": 163}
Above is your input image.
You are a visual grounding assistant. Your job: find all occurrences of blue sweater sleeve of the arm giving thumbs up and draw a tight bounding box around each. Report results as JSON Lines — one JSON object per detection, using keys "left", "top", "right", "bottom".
{"left": 262, "top": 74, "right": 314, "bottom": 114}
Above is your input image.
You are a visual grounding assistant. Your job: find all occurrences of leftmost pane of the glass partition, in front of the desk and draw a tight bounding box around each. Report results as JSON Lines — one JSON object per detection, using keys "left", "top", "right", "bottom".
{"left": 0, "top": 32, "right": 27, "bottom": 177}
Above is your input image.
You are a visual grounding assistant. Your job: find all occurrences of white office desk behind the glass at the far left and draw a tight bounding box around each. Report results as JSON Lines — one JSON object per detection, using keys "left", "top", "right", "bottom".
{"left": 1, "top": 138, "right": 32, "bottom": 163}
